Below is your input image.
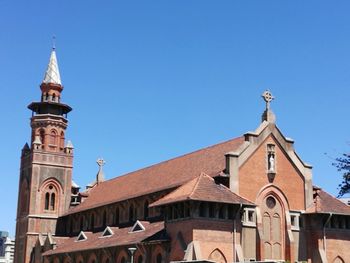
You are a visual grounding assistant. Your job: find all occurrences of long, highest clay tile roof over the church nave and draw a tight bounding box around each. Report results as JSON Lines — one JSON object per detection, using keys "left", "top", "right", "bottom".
{"left": 67, "top": 137, "right": 244, "bottom": 214}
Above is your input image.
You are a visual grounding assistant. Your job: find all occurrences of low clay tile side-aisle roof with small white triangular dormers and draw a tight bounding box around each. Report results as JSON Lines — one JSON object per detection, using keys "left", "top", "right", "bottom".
{"left": 43, "top": 221, "right": 167, "bottom": 256}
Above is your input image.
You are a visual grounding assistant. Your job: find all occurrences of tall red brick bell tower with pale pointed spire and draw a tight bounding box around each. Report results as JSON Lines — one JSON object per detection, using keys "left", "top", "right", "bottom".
{"left": 15, "top": 48, "right": 73, "bottom": 263}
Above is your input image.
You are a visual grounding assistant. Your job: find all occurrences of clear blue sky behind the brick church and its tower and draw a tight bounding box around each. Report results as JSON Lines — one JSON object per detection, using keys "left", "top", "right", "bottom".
{"left": 0, "top": 0, "right": 350, "bottom": 236}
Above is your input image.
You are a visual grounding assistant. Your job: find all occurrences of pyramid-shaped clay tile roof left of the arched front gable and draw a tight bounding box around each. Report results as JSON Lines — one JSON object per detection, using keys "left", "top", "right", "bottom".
{"left": 150, "top": 173, "right": 253, "bottom": 207}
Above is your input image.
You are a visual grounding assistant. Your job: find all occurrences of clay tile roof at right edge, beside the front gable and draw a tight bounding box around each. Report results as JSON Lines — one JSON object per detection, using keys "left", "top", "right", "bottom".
{"left": 306, "top": 186, "right": 350, "bottom": 215}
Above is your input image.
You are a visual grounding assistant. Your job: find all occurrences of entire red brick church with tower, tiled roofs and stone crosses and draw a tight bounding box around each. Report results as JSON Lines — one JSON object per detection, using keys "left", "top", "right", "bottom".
{"left": 15, "top": 50, "right": 350, "bottom": 263}
